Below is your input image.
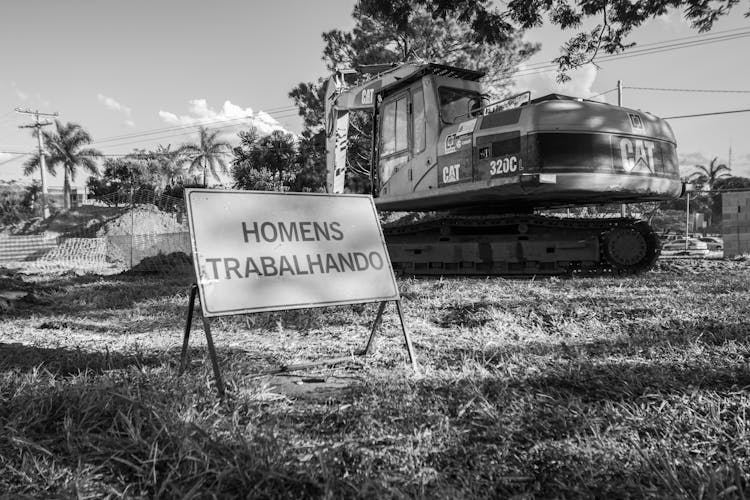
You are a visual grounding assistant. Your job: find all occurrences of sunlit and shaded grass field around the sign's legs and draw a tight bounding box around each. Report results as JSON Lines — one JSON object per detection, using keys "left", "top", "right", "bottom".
{"left": 0, "top": 261, "right": 750, "bottom": 498}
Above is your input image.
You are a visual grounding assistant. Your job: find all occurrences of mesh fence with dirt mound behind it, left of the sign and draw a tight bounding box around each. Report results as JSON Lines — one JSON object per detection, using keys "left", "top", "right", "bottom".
{"left": 0, "top": 191, "right": 192, "bottom": 274}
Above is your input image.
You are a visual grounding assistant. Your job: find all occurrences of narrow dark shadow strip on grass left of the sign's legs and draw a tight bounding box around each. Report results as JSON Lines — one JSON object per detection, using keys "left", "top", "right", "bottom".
{"left": 0, "top": 342, "right": 164, "bottom": 376}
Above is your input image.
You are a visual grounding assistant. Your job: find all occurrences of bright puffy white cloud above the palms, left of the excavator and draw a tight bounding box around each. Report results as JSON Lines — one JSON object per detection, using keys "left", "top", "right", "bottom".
{"left": 159, "top": 99, "right": 286, "bottom": 134}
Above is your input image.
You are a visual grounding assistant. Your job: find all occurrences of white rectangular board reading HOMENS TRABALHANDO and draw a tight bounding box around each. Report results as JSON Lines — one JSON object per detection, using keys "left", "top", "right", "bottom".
{"left": 185, "top": 189, "right": 399, "bottom": 316}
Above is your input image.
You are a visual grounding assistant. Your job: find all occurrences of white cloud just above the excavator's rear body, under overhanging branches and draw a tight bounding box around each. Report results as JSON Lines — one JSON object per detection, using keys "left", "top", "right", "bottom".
{"left": 514, "top": 63, "right": 607, "bottom": 102}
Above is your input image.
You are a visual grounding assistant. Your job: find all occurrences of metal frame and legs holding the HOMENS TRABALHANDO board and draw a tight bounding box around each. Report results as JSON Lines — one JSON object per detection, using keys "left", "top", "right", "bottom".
{"left": 179, "top": 188, "right": 419, "bottom": 397}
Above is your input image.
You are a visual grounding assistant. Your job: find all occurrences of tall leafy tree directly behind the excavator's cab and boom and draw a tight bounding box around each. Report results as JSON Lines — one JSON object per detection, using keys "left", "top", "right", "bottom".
{"left": 289, "top": 0, "right": 538, "bottom": 191}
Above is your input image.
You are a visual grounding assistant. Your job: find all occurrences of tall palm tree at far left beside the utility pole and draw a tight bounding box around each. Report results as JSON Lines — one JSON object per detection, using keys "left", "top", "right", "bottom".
{"left": 24, "top": 120, "right": 102, "bottom": 210}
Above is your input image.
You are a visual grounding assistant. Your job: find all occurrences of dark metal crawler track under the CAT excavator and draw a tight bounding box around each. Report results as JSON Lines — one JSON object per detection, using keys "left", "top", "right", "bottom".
{"left": 383, "top": 214, "right": 661, "bottom": 277}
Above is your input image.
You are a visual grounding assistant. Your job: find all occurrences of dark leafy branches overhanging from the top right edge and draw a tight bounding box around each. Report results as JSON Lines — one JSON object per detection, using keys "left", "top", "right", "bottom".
{"left": 361, "top": 0, "right": 750, "bottom": 81}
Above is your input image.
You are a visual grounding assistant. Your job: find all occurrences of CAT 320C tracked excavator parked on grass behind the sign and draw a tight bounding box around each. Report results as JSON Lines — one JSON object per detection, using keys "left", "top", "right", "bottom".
{"left": 325, "top": 63, "right": 685, "bottom": 277}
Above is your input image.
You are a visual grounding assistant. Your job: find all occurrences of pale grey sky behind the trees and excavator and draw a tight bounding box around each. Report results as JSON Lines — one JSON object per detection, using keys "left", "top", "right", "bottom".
{"left": 0, "top": 0, "right": 750, "bottom": 186}
